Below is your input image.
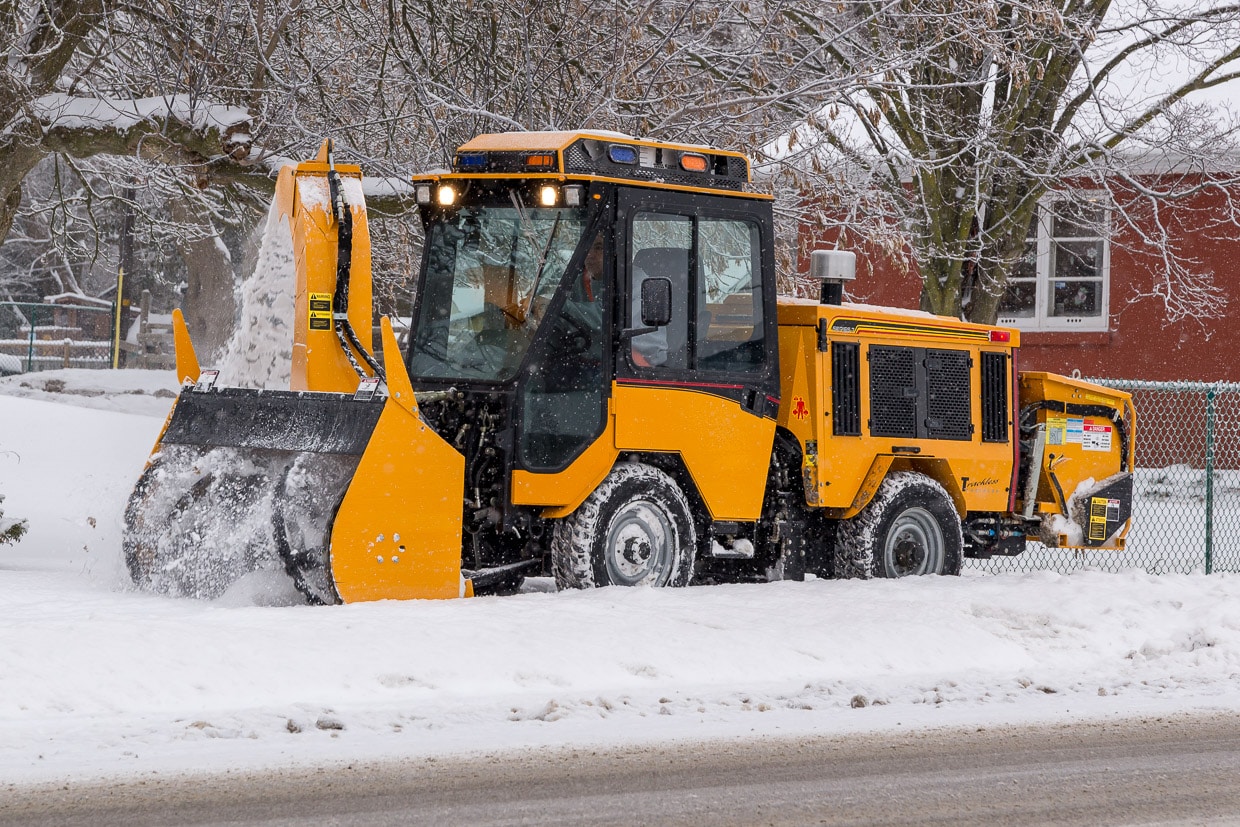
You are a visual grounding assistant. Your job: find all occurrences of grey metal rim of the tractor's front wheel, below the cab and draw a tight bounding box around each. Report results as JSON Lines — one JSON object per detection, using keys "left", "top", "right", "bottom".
{"left": 604, "top": 500, "right": 678, "bottom": 585}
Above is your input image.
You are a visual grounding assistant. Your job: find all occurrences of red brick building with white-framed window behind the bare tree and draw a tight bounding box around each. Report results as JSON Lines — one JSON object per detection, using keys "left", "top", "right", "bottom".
{"left": 823, "top": 175, "right": 1240, "bottom": 382}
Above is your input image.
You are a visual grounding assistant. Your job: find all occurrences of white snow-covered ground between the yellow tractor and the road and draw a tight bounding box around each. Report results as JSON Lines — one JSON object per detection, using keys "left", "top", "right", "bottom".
{"left": 0, "top": 371, "right": 1240, "bottom": 782}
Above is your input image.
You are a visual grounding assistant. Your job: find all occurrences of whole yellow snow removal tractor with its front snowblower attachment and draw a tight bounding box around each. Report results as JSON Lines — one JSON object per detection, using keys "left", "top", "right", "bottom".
{"left": 124, "top": 133, "right": 1135, "bottom": 603}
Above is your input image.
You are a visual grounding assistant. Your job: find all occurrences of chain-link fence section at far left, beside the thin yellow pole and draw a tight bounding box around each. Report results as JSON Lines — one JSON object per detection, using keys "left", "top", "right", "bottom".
{"left": 0, "top": 301, "right": 115, "bottom": 376}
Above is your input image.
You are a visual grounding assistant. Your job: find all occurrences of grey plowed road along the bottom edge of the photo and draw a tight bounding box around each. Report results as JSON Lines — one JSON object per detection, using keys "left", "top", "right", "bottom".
{"left": 0, "top": 713, "right": 1240, "bottom": 827}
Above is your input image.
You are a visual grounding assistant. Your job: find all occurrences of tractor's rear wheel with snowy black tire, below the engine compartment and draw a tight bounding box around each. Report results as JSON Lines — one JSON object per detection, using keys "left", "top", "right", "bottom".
{"left": 835, "top": 471, "right": 965, "bottom": 578}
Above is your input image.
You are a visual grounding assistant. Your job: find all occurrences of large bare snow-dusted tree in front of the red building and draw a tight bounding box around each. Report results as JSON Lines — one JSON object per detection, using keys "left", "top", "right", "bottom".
{"left": 775, "top": 0, "right": 1240, "bottom": 322}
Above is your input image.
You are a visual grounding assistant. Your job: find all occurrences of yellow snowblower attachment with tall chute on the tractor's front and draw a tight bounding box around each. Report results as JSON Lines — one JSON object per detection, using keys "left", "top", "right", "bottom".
{"left": 124, "top": 145, "right": 470, "bottom": 603}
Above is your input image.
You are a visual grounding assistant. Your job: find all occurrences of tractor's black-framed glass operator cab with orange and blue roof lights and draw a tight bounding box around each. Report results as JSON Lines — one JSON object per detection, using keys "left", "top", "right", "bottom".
{"left": 407, "top": 133, "right": 779, "bottom": 560}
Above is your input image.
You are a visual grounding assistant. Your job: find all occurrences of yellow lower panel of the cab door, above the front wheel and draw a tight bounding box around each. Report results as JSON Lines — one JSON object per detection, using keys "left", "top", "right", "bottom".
{"left": 613, "top": 383, "right": 775, "bottom": 521}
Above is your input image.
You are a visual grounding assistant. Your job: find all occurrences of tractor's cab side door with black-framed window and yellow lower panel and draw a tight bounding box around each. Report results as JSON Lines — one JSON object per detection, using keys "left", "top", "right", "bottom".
{"left": 614, "top": 188, "right": 779, "bottom": 521}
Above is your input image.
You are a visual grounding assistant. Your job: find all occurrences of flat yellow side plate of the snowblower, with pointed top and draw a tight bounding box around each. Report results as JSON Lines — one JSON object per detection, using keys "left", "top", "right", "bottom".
{"left": 329, "top": 319, "right": 467, "bottom": 603}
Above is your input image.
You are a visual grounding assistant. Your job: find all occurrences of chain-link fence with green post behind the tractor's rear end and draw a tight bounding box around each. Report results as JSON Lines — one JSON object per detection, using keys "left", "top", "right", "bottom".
{"left": 965, "top": 379, "right": 1240, "bottom": 574}
